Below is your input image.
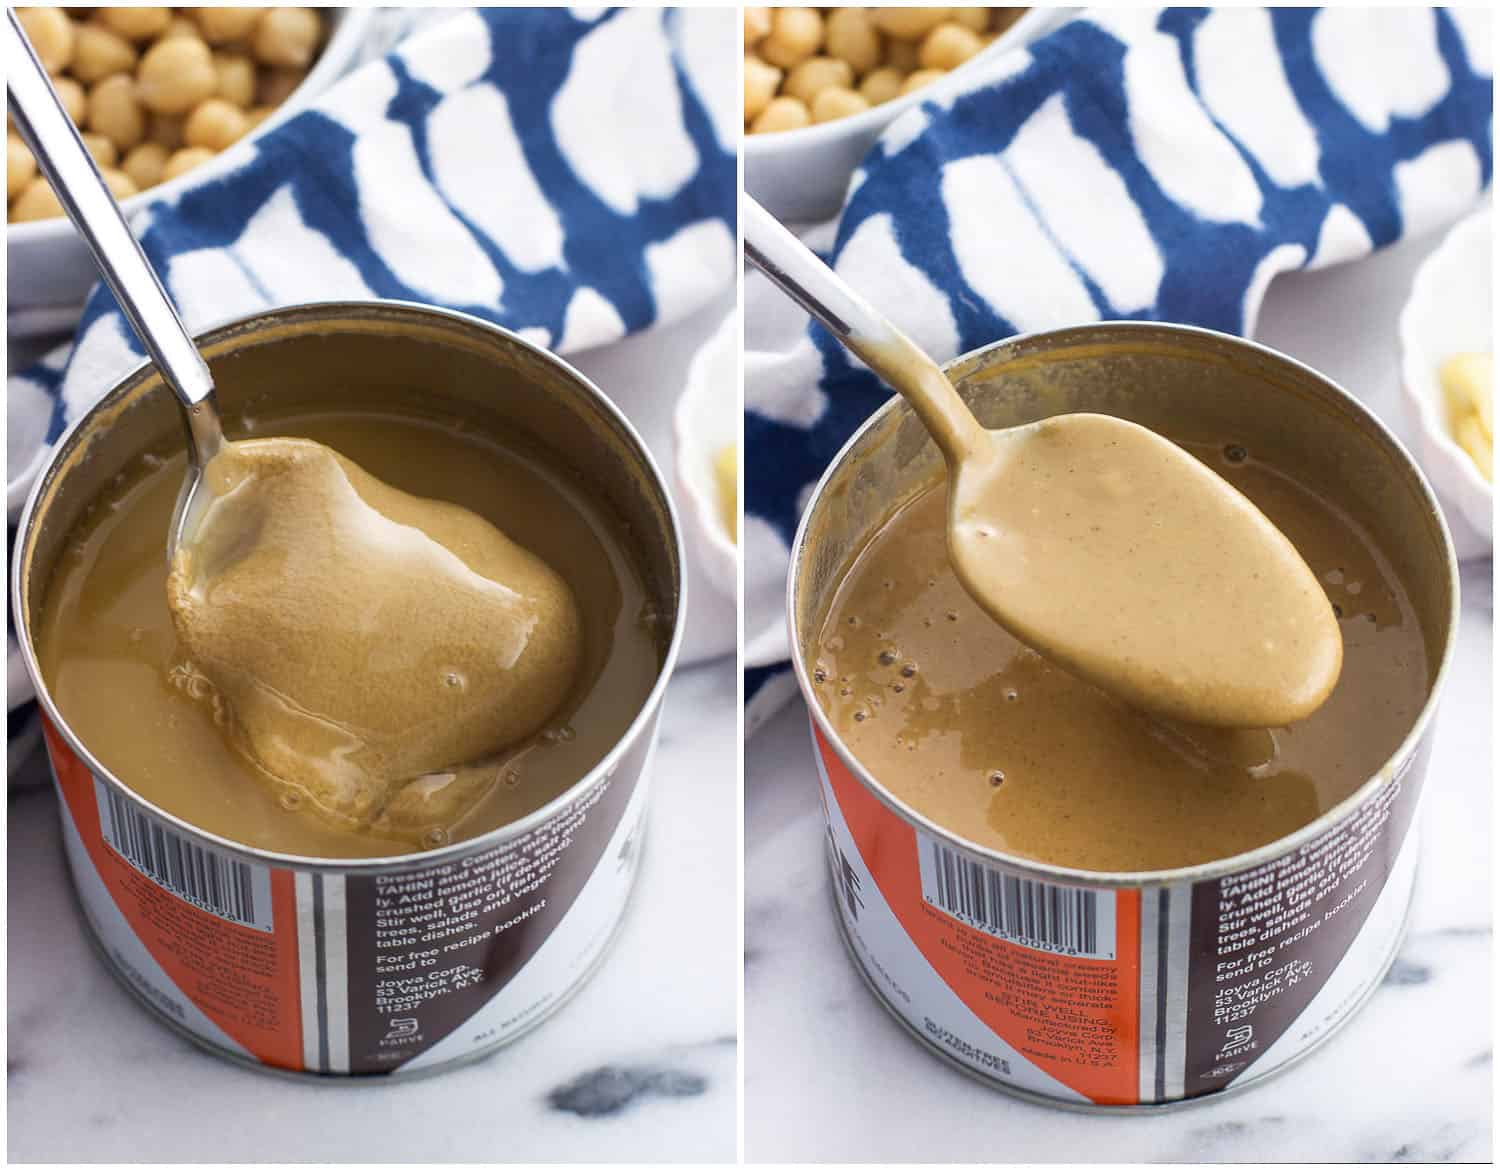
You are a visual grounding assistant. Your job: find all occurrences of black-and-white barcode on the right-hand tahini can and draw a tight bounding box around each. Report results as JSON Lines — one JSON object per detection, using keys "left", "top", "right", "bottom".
{"left": 918, "top": 835, "right": 1115, "bottom": 960}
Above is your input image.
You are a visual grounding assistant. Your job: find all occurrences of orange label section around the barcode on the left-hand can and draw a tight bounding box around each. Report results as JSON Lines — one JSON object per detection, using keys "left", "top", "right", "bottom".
{"left": 42, "top": 717, "right": 303, "bottom": 1069}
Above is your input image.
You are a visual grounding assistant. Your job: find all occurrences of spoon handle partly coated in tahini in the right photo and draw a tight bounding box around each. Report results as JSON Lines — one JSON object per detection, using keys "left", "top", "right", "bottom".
{"left": 740, "top": 195, "right": 986, "bottom": 463}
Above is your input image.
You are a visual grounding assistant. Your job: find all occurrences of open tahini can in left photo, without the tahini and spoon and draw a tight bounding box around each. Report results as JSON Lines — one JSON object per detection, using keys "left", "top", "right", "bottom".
{"left": 12, "top": 301, "right": 684, "bottom": 1077}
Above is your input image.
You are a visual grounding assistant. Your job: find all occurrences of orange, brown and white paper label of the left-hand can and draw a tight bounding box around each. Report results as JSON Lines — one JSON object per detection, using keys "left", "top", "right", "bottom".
{"left": 44, "top": 707, "right": 654, "bottom": 1074}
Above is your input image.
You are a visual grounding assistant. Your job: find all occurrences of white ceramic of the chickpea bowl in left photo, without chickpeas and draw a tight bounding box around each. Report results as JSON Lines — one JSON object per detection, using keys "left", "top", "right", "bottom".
{"left": 6, "top": 7, "right": 375, "bottom": 333}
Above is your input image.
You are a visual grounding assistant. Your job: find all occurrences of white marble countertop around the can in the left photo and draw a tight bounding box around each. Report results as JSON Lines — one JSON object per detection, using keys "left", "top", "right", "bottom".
{"left": 8, "top": 289, "right": 740, "bottom": 1162}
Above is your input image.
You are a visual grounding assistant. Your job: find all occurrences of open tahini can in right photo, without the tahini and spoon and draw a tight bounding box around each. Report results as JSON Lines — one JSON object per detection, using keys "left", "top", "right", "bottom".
{"left": 788, "top": 322, "right": 1458, "bottom": 1110}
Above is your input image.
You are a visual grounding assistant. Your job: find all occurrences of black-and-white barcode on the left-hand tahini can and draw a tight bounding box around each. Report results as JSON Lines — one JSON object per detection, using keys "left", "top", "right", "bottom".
{"left": 95, "top": 778, "right": 272, "bottom": 931}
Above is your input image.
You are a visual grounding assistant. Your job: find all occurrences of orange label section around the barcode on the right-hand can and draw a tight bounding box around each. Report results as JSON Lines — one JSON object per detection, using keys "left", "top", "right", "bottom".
{"left": 815, "top": 729, "right": 1140, "bottom": 1105}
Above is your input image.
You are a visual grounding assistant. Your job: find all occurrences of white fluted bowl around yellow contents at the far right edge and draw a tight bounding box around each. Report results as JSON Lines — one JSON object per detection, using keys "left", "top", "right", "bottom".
{"left": 1400, "top": 204, "right": 1494, "bottom": 556}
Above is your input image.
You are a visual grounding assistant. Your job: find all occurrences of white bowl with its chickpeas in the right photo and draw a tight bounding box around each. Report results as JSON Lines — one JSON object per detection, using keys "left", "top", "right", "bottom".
{"left": 744, "top": 7, "right": 1077, "bottom": 223}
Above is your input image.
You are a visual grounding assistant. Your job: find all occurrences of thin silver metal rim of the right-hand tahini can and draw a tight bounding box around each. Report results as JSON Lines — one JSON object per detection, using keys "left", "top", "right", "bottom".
{"left": 786, "top": 321, "right": 1460, "bottom": 889}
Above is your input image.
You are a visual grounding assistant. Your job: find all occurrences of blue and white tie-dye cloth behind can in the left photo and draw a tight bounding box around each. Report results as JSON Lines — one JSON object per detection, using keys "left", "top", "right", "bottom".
{"left": 8, "top": 9, "right": 741, "bottom": 773}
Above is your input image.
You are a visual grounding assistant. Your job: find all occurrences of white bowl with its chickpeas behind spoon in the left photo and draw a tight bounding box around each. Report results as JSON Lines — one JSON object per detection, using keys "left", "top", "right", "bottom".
{"left": 6, "top": 7, "right": 371, "bottom": 328}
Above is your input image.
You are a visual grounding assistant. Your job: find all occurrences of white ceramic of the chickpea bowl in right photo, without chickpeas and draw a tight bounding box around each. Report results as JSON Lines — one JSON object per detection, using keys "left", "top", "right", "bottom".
{"left": 744, "top": 7, "right": 1079, "bottom": 223}
